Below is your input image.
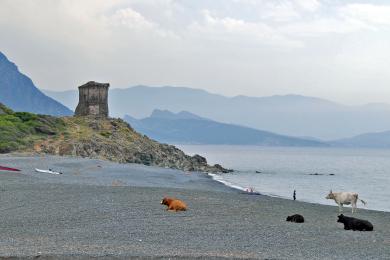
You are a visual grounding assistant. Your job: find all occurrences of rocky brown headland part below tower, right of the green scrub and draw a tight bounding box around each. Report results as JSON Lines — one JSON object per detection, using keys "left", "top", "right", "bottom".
{"left": 40, "top": 117, "right": 232, "bottom": 172}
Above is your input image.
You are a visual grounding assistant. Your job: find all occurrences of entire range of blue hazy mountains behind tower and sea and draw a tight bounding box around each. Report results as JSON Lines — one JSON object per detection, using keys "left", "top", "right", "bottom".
{"left": 0, "top": 52, "right": 390, "bottom": 148}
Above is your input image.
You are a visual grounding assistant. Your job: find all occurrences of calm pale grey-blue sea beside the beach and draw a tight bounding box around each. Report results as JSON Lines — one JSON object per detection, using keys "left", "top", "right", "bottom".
{"left": 179, "top": 145, "right": 390, "bottom": 211}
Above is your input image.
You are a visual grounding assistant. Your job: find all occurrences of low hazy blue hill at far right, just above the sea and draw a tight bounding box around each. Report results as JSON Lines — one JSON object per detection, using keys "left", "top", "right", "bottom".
{"left": 329, "top": 131, "right": 390, "bottom": 148}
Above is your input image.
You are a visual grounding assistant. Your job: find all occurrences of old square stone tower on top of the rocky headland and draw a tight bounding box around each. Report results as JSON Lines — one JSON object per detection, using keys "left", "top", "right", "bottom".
{"left": 75, "top": 81, "right": 110, "bottom": 117}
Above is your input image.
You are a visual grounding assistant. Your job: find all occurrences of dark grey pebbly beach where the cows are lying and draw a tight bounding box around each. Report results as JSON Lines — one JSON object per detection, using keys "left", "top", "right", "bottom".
{"left": 0, "top": 156, "right": 390, "bottom": 259}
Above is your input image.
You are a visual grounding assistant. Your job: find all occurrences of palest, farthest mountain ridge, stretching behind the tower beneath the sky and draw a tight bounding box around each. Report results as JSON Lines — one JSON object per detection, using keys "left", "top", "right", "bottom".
{"left": 46, "top": 86, "right": 390, "bottom": 140}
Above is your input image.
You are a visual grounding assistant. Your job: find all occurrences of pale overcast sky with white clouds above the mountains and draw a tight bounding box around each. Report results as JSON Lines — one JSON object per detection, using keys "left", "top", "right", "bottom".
{"left": 0, "top": 0, "right": 390, "bottom": 104}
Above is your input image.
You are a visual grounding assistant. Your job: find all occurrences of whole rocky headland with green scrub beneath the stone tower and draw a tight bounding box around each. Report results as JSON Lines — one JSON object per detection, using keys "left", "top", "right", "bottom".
{"left": 0, "top": 105, "right": 227, "bottom": 172}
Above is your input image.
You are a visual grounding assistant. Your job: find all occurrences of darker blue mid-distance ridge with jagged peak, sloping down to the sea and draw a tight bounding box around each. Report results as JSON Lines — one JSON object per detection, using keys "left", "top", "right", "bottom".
{"left": 124, "top": 110, "right": 326, "bottom": 146}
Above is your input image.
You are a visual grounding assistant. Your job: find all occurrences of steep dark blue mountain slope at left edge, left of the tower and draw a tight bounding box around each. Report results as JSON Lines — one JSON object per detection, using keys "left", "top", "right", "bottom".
{"left": 0, "top": 52, "right": 73, "bottom": 116}
